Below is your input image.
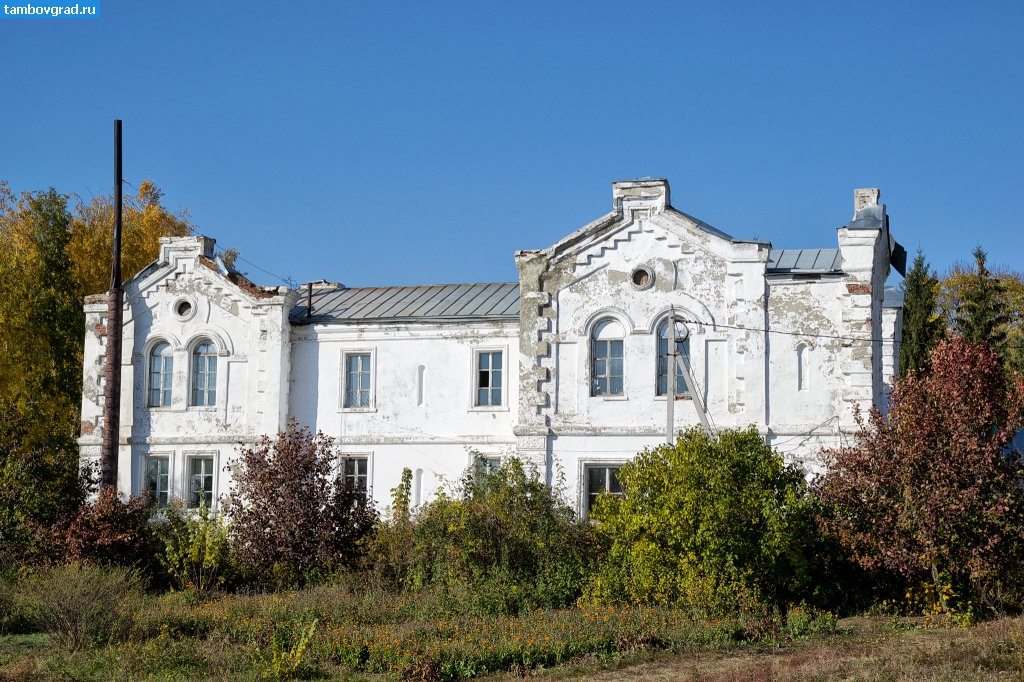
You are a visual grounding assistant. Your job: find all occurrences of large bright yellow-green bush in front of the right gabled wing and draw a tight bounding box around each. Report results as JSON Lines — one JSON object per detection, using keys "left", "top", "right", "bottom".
{"left": 588, "top": 426, "right": 817, "bottom": 611}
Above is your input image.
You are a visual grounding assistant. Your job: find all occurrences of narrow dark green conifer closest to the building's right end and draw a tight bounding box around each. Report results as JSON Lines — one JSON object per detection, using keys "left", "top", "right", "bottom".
{"left": 899, "top": 249, "right": 945, "bottom": 376}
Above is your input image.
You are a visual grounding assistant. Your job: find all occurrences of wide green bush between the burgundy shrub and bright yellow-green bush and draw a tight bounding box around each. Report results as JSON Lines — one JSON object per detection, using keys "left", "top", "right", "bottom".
{"left": 395, "top": 458, "right": 597, "bottom": 613}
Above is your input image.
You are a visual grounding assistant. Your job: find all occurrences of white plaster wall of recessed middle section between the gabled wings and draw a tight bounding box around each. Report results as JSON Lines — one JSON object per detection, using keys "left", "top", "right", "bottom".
{"left": 290, "top": 323, "right": 518, "bottom": 506}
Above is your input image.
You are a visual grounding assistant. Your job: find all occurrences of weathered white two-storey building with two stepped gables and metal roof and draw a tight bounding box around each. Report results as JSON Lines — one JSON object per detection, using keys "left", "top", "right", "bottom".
{"left": 79, "top": 179, "right": 905, "bottom": 514}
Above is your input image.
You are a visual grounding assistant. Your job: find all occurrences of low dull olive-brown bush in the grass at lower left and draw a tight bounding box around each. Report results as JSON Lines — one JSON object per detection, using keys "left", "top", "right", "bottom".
{"left": 24, "top": 564, "right": 143, "bottom": 651}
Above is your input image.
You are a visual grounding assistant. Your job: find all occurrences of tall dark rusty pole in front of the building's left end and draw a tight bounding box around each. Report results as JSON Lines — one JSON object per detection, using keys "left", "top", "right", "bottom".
{"left": 100, "top": 120, "right": 124, "bottom": 489}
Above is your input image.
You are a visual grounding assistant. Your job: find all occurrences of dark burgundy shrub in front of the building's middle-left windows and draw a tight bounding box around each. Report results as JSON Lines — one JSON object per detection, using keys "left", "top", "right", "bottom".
{"left": 225, "top": 420, "right": 376, "bottom": 585}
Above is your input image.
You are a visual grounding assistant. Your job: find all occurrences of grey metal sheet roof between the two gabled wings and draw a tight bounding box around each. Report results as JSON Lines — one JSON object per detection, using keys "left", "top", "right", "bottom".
{"left": 291, "top": 282, "right": 519, "bottom": 325}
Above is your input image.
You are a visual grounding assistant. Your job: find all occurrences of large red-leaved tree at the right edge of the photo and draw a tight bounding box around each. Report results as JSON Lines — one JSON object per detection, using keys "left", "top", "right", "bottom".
{"left": 814, "top": 336, "right": 1024, "bottom": 607}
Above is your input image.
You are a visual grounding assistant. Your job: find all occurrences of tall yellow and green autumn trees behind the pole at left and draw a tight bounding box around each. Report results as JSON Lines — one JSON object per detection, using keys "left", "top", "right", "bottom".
{"left": 0, "top": 181, "right": 194, "bottom": 551}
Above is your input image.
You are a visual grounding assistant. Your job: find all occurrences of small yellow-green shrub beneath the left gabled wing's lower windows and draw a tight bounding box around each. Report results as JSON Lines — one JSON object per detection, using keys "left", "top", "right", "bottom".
{"left": 158, "top": 503, "right": 236, "bottom": 592}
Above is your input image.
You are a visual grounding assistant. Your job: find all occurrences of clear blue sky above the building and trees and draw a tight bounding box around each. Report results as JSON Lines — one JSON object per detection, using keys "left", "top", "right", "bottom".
{"left": 0, "top": 0, "right": 1024, "bottom": 286}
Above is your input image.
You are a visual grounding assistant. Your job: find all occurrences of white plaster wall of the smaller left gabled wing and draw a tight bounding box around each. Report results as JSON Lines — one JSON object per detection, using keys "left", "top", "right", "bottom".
{"left": 79, "top": 237, "right": 294, "bottom": 499}
